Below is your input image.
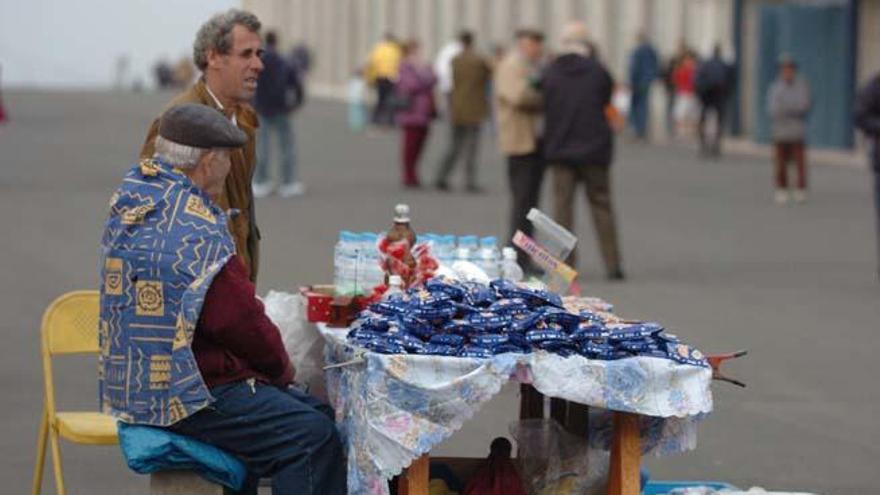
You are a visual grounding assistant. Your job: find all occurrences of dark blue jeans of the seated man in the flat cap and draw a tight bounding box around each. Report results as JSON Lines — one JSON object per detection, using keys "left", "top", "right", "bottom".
{"left": 170, "top": 381, "right": 347, "bottom": 495}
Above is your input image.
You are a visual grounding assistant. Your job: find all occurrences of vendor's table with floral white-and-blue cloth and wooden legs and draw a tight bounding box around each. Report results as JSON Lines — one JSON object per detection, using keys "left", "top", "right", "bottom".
{"left": 318, "top": 324, "right": 712, "bottom": 495}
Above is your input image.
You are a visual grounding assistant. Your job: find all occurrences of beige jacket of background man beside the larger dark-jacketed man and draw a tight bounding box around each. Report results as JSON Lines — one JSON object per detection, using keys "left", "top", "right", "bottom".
{"left": 495, "top": 50, "right": 542, "bottom": 155}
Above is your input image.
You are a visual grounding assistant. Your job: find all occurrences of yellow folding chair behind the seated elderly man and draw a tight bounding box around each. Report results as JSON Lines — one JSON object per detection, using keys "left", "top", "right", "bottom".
{"left": 33, "top": 290, "right": 118, "bottom": 495}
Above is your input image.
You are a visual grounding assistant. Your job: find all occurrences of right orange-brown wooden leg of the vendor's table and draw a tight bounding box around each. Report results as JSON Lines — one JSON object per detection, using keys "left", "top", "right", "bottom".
{"left": 608, "top": 412, "right": 642, "bottom": 495}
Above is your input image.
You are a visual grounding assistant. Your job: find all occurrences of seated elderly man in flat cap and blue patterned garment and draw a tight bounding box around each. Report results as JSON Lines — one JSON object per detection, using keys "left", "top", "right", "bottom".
{"left": 99, "top": 104, "right": 346, "bottom": 494}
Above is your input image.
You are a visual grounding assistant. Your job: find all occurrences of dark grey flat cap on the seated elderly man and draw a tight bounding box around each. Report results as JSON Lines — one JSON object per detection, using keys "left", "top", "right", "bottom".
{"left": 159, "top": 103, "right": 247, "bottom": 149}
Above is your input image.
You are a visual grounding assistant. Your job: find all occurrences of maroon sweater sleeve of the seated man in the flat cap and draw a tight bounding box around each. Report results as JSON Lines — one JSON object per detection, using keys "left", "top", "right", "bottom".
{"left": 192, "top": 255, "right": 294, "bottom": 388}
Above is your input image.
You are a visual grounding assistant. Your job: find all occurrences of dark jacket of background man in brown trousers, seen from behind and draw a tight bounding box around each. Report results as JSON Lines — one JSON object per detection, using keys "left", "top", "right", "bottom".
{"left": 541, "top": 54, "right": 614, "bottom": 165}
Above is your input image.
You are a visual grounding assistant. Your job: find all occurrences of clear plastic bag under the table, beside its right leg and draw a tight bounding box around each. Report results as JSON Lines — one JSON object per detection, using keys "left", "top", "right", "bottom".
{"left": 510, "top": 419, "right": 609, "bottom": 495}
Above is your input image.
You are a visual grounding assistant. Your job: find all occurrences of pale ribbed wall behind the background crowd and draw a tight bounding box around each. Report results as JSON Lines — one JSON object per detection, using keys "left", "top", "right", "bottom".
{"left": 242, "top": 0, "right": 733, "bottom": 92}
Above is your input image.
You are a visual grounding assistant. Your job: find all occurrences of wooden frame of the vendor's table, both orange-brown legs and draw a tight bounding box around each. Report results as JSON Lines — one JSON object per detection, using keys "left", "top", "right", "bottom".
{"left": 398, "top": 412, "right": 642, "bottom": 495}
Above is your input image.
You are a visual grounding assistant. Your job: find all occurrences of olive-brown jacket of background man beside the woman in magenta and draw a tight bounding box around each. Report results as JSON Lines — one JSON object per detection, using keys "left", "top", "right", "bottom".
{"left": 451, "top": 50, "right": 492, "bottom": 125}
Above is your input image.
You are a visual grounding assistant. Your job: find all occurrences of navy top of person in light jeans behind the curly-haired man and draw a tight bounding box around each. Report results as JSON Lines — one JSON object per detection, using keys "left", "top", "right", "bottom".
{"left": 254, "top": 48, "right": 305, "bottom": 116}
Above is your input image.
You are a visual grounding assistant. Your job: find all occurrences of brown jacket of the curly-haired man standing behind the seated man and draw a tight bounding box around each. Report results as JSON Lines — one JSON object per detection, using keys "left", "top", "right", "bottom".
{"left": 141, "top": 80, "right": 260, "bottom": 281}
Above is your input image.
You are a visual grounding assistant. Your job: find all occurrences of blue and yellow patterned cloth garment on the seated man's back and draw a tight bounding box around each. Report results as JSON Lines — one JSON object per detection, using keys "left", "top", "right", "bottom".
{"left": 98, "top": 159, "right": 235, "bottom": 426}
